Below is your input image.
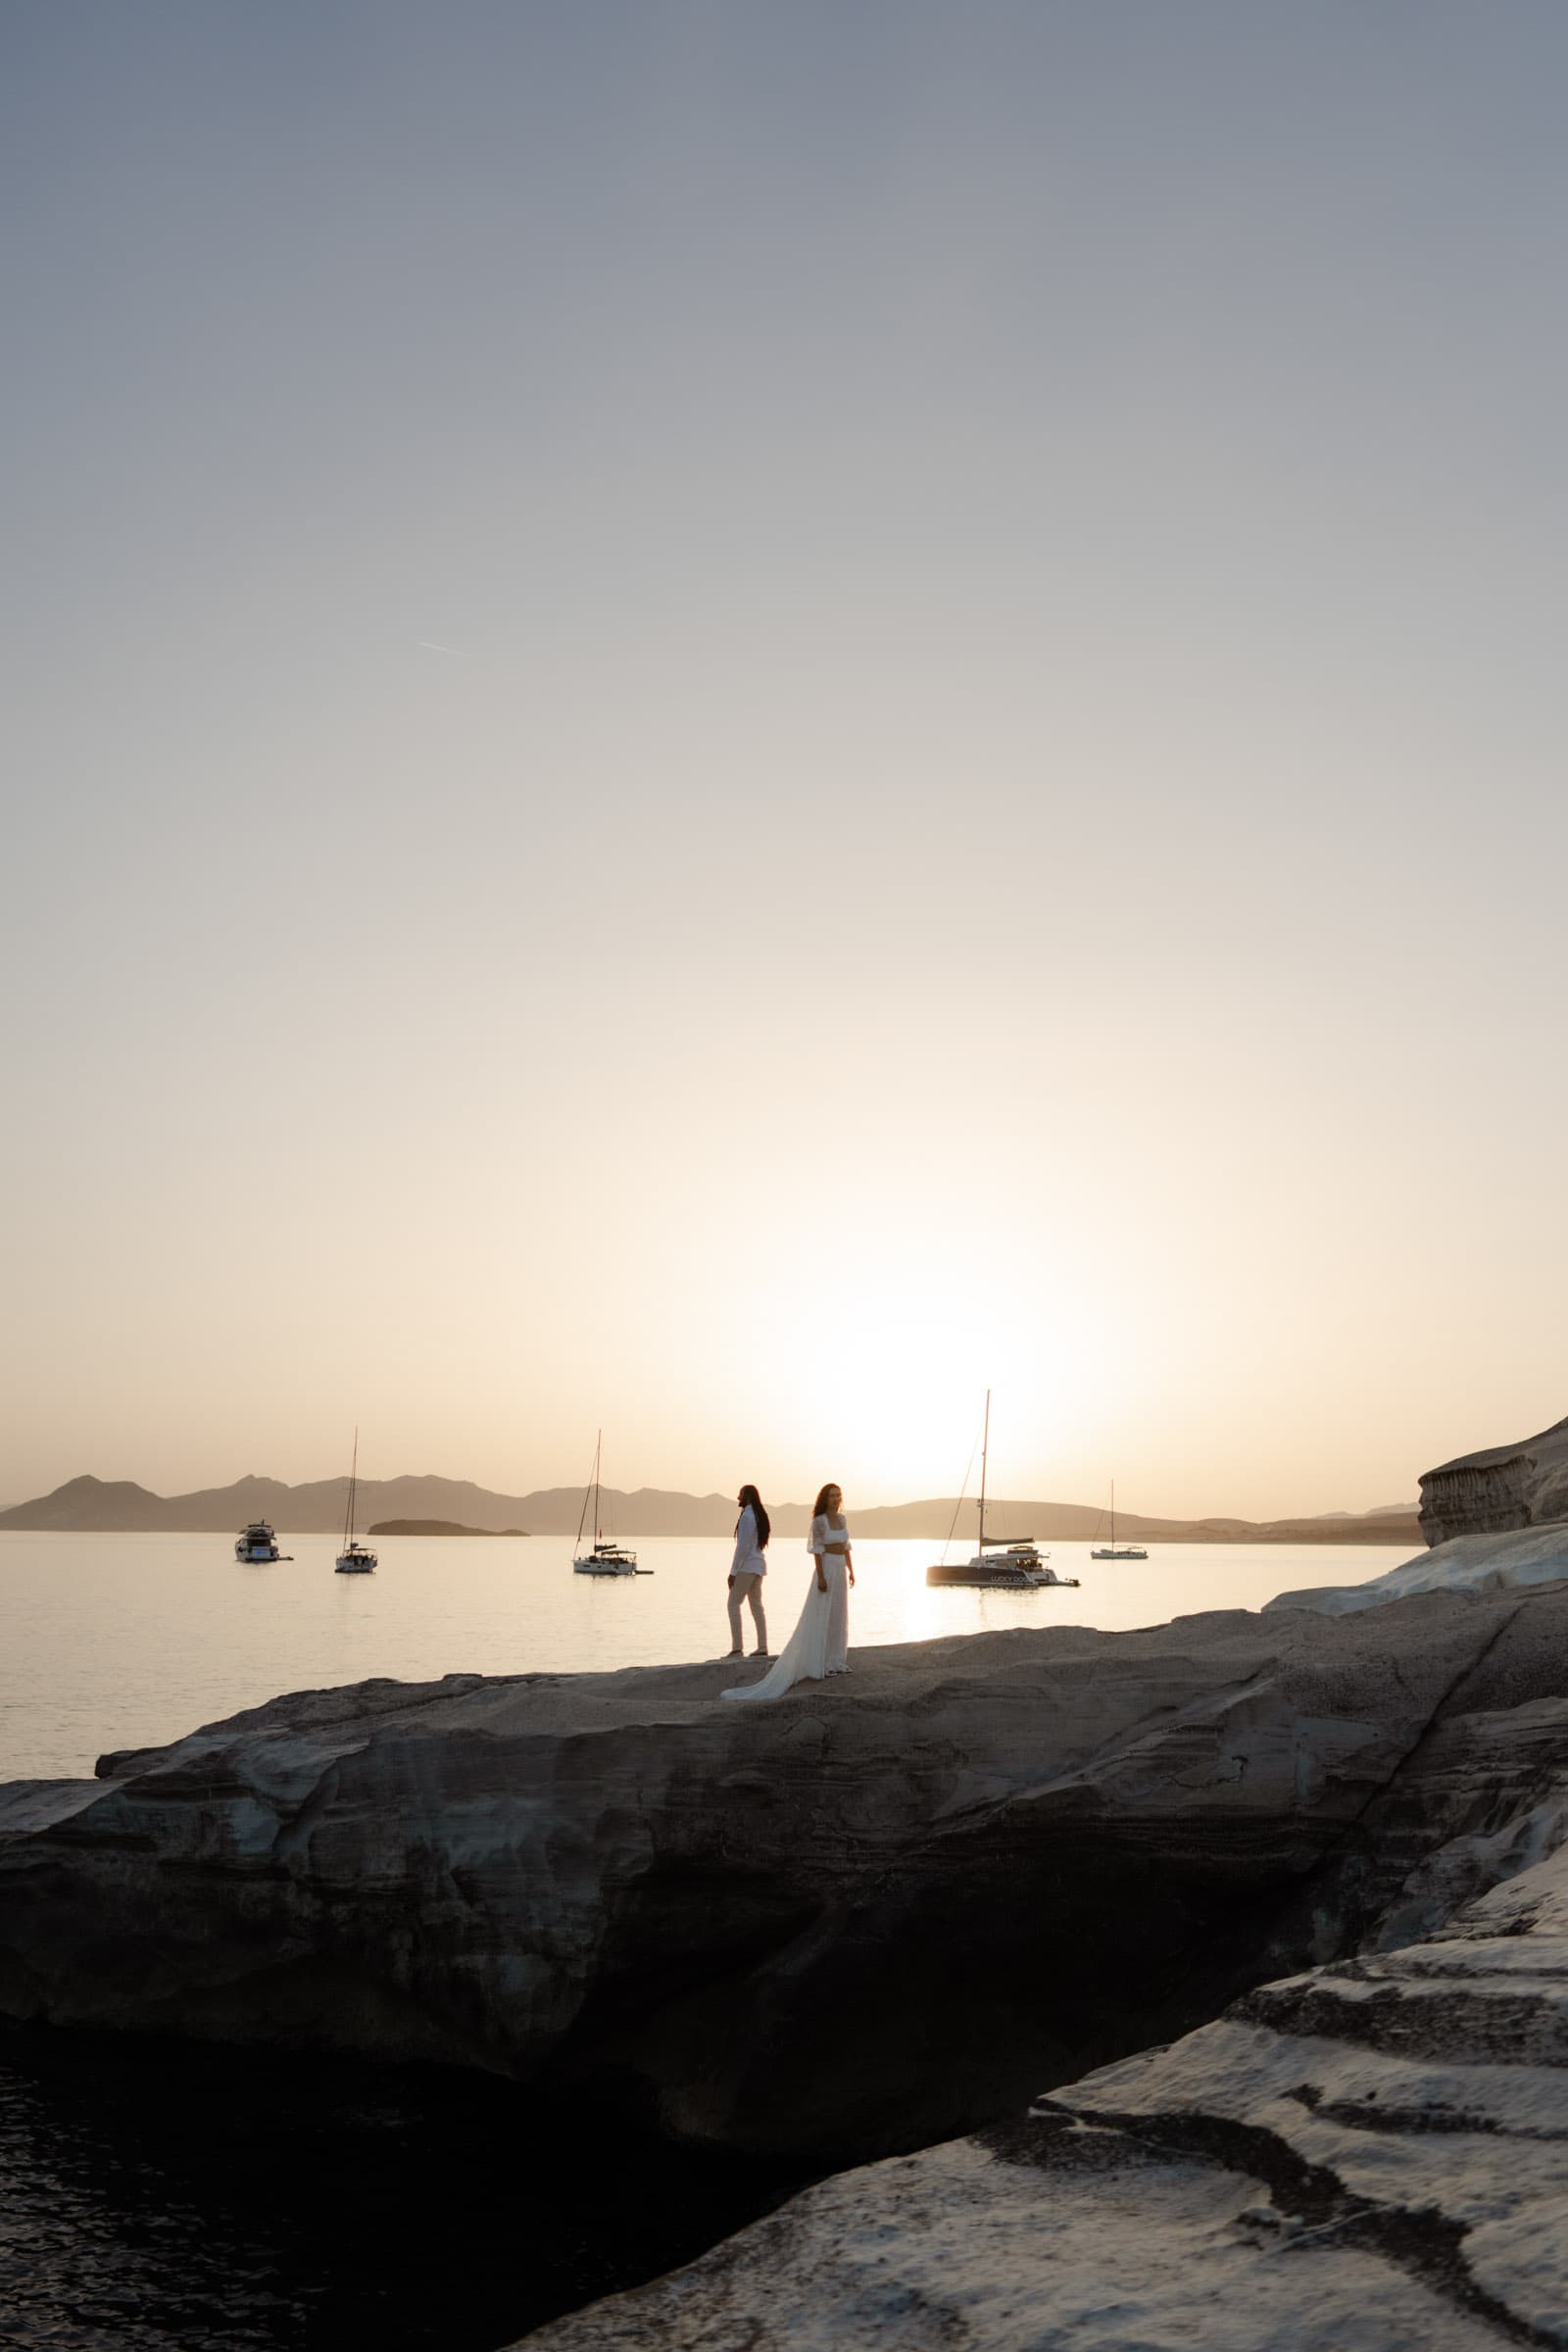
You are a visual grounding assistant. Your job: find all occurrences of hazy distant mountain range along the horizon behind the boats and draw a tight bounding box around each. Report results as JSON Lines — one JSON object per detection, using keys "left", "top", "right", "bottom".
{"left": 0, "top": 1477, "right": 1422, "bottom": 1547}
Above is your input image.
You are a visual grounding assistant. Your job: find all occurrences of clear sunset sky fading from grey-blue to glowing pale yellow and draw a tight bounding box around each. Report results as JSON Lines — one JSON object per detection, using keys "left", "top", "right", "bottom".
{"left": 0, "top": 0, "right": 1568, "bottom": 1515}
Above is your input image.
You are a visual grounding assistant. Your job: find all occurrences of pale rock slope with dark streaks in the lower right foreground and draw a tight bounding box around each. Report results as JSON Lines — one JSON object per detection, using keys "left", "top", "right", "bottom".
{"left": 529, "top": 1806, "right": 1568, "bottom": 2352}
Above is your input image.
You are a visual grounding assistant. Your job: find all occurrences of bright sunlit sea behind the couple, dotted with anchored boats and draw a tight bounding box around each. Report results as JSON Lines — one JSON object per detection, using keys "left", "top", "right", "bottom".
{"left": 0, "top": 1531, "right": 1408, "bottom": 1781}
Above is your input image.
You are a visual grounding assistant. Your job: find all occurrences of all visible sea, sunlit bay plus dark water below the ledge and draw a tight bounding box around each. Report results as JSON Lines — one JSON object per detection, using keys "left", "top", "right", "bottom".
{"left": 0, "top": 1534, "right": 1403, "bottom": 2352}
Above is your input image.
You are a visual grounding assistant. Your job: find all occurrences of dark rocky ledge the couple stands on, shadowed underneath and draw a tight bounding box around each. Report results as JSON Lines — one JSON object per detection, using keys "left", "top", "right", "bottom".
{"left": 0, "top": 1586, "right": 1568, "bottom": 2182}
